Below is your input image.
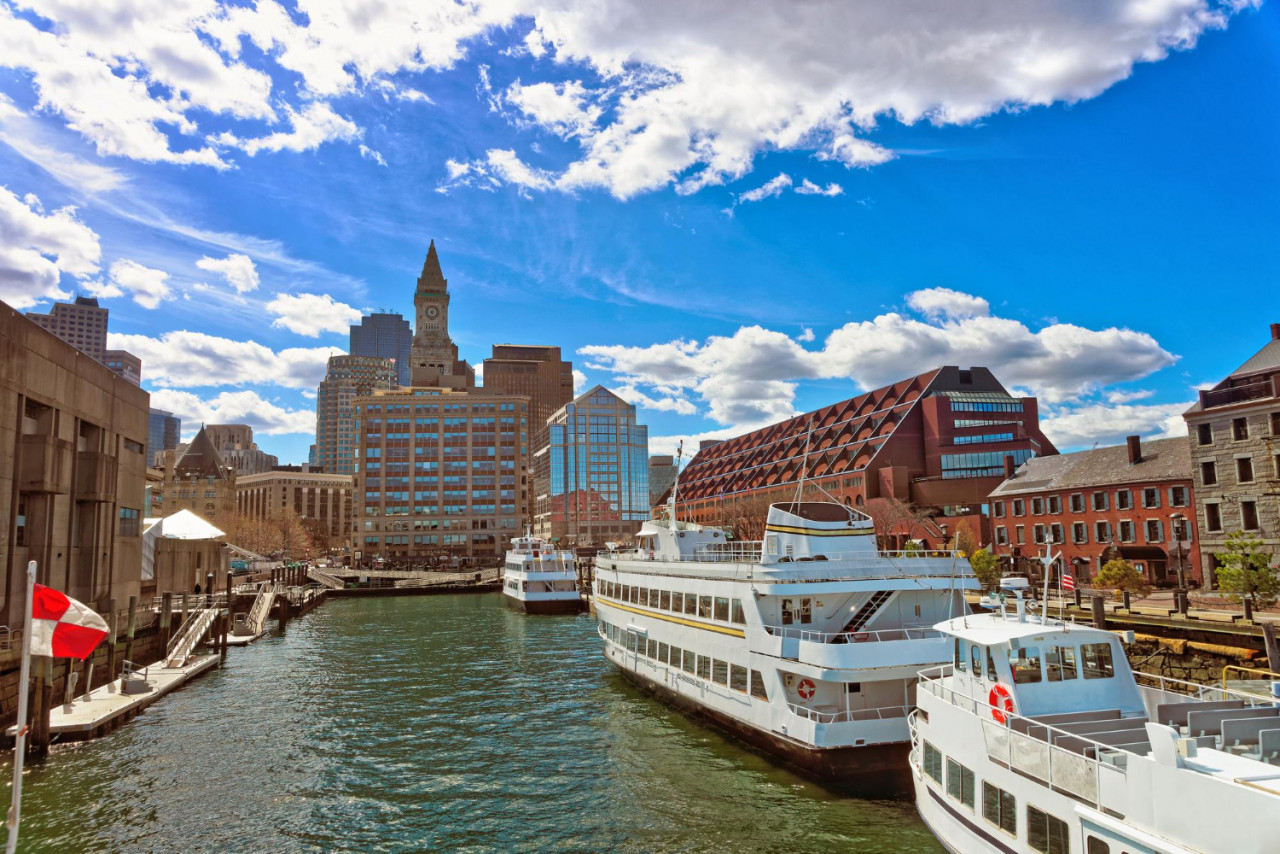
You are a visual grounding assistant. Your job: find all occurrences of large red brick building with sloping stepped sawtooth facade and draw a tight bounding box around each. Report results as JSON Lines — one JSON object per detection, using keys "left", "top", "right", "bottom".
{"left": 677, "top": 366, "right": 1057, "bottom": 545}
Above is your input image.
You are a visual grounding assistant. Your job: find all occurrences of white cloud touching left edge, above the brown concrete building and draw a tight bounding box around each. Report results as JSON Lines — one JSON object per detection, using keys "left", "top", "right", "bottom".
{"left": 0, "top": 187, "right": 102, "bottom": 309}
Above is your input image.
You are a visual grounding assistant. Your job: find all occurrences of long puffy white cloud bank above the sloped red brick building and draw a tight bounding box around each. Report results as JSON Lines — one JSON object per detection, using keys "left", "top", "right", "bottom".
{"left": 577, "top": 289, "right": 1176, "bottom": 429}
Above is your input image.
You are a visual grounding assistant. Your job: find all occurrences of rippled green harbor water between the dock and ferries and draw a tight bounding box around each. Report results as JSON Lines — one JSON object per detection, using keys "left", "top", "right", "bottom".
{"left": 10, "top": 595, "right": 942, "bottom": 854}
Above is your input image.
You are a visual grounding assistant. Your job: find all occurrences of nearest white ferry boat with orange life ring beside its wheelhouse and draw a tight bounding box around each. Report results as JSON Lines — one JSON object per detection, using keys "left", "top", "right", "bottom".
{"left": 911, "top": 579, "right": 1280, "bottom": 854}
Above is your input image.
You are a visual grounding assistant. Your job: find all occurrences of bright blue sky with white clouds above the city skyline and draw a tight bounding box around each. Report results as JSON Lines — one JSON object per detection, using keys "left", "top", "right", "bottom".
{"left": 0, "top": 0, "right": 1280, "bottom": 462}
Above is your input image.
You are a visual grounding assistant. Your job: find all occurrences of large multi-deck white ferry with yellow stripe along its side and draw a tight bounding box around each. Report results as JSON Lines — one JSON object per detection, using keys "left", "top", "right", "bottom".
{"left": 594, "top": 502, "right": 978, "bottom": 789}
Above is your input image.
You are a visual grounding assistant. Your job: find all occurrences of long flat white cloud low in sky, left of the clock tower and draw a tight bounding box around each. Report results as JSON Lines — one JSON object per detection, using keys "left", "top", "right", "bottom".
{"left": 106, "top": 330, "right": 342, "bottom": 388}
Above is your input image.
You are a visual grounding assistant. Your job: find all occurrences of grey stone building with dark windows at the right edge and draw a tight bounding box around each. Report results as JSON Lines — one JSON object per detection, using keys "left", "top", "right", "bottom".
{"left": 1183, "top": 323, "right": 1280, "bottom": 585}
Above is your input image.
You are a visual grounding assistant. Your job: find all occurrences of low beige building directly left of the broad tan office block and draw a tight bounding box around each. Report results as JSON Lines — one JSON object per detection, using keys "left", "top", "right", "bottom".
{"left": 236, "top": 466, "right": 355, "bottom": 549}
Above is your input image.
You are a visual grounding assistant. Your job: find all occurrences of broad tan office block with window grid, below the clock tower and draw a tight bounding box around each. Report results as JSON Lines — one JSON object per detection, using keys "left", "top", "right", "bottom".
{"left": 352, "top": 388, "right": 529, "bottom": 562}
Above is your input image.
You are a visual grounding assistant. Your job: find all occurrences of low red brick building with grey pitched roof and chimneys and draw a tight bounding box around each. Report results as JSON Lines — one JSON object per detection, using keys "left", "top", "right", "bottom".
{"left": 991, "top": 435, "right": 1202, "bottom": 586}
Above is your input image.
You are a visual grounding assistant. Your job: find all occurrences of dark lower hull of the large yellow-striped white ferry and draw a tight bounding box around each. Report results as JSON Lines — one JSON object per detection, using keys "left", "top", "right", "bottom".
{"left": 614, "top": 662, "right": 911, "bottom": 798}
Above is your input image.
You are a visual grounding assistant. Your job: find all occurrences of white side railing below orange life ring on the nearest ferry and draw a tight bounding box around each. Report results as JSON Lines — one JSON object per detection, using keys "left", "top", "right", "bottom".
{"left": 918, "top": 665, "right": 1130, "bottom": 814}
